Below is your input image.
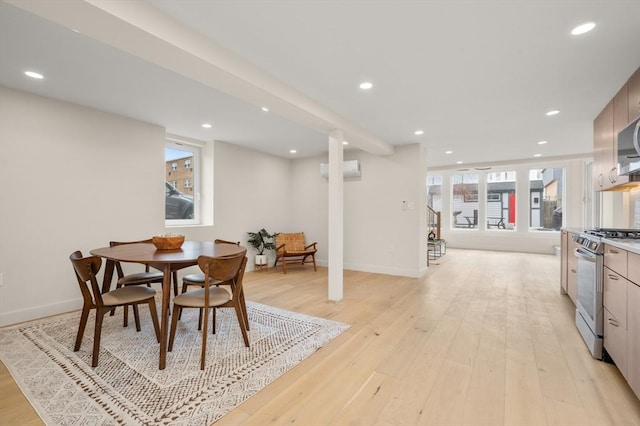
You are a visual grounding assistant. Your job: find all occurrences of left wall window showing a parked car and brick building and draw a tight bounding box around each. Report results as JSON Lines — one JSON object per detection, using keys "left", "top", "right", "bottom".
{"left": 164, "top": 141, "right": 200, "bottom": 226}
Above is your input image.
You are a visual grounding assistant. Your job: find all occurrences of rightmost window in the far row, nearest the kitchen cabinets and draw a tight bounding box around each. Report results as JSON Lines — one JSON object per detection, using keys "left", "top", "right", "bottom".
{"left": 529, "top": 168, "right": 564, "bottom": 231}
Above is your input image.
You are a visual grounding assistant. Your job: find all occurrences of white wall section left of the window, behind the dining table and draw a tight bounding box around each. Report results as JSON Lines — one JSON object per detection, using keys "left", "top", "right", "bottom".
{"left": 0, "top": 88, "right": 165, "bottom": 325}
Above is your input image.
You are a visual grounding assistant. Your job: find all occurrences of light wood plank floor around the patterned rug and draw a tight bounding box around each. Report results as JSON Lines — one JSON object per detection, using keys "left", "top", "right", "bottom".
{"left": 0, "top": 250, "right": 640, "bottom": 426}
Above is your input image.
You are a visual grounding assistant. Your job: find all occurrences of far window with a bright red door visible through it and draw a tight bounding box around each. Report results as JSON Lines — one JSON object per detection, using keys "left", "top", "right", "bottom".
{"left": 486, "top": 171, "right": 516, "bottom": 230}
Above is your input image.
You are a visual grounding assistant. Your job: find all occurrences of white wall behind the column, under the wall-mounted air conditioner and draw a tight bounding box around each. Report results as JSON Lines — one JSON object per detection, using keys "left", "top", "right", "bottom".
{"left": 292, "top": 144, "right": 426, "bottom": 277}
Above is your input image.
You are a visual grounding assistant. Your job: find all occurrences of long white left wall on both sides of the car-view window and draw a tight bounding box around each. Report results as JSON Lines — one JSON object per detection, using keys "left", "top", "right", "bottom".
{"left": 0, "top": 88, "right": 291, "bottom": 326}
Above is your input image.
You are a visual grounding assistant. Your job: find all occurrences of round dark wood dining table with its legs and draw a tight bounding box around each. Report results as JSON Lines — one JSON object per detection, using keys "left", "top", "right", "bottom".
{"left": 90, "top": 241, "right": 246, "bottom": 370}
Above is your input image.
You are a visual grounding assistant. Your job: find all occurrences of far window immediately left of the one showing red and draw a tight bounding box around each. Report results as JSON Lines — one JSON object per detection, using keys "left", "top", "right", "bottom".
{"left": 451, "top": 173, "right": 479, "bottom": 229}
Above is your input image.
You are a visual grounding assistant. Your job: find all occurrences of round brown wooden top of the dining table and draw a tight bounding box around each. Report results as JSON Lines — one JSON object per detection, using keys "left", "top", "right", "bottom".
{"left": 91, "top": 241, "right": 245, "bottom": 264}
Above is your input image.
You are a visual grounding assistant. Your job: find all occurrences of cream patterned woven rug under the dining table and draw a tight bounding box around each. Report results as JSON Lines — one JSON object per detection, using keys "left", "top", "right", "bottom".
{"left": 0, "top": 301, "right": 349, "bottom": 425}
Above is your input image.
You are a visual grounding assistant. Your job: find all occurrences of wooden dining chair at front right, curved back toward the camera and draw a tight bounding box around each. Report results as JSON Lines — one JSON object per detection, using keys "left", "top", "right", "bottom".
{"left": 168, "top": 250, "right": 249, "bottom": 370}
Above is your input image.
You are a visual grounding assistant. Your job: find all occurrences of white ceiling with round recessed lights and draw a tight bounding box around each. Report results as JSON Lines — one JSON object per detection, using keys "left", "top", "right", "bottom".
{"left": 0, "top": 0, "right": 640, "bottom": 167}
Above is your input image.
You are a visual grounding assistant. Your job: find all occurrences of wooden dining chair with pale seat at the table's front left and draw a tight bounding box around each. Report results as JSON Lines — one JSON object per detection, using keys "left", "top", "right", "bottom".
{"left": 69, "top": 251, "right": 160, "bottom": 367}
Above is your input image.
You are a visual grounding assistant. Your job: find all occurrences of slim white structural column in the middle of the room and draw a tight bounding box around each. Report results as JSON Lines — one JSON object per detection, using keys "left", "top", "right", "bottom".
{"left": 328, "top": 129, "right": 344, "bottom": 301}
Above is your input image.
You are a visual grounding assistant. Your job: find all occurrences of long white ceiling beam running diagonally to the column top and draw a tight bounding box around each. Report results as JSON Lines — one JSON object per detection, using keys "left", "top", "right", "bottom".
{"left": 7, "top": 0, "right": 393, "bottom": 155}
